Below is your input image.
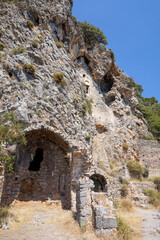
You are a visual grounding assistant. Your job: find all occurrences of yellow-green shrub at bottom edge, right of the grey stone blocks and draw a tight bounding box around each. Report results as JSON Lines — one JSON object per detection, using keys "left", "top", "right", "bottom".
{"left": 117, "top": 216, "right": 132, "bottom": 240}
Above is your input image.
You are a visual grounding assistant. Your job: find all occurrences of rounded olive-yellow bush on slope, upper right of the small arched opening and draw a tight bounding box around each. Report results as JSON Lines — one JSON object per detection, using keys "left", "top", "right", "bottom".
{"left": 127, "top": 161, "right": 144, "bottom": 179}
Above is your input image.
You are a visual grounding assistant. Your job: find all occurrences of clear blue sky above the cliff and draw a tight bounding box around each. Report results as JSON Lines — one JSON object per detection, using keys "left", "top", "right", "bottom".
{"left": 72, "top": 0, "right": 160, "bottom": 102}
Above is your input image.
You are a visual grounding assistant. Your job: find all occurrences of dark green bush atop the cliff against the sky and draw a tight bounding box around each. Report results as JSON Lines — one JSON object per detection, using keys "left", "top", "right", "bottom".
{"left": 79, "top": 21, "right": 108, "bottom": 48}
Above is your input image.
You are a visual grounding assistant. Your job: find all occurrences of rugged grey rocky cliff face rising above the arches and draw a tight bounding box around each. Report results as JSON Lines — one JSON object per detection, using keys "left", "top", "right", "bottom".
{"left": 0, "top": 0, "right": 159, "bottom": 182}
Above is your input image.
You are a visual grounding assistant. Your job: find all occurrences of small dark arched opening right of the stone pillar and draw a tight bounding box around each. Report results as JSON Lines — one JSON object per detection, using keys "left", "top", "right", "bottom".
{"left": 90, "top": 174, "right": 107, "bottom": 192}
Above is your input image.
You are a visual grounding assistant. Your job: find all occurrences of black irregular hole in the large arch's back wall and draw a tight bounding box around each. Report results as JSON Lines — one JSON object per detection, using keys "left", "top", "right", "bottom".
{"left": 28, "top": 148, "right": 43, "bottom": 172}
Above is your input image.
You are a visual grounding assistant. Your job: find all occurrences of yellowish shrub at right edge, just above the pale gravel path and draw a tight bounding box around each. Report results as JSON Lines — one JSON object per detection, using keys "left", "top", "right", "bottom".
{"left": 144, "top": 188, "right": 160, "bottom": 207}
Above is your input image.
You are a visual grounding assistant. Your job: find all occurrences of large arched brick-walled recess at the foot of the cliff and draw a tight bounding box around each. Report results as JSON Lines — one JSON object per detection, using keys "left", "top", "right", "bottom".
{"left": 2, "top": 129, "right": 71, "bottom": 209}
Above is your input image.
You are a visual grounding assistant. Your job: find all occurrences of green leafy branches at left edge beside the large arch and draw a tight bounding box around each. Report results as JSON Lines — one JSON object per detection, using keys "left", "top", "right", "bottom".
{"left": 0, "top": 113, "right": 26, "bottom": 172}
